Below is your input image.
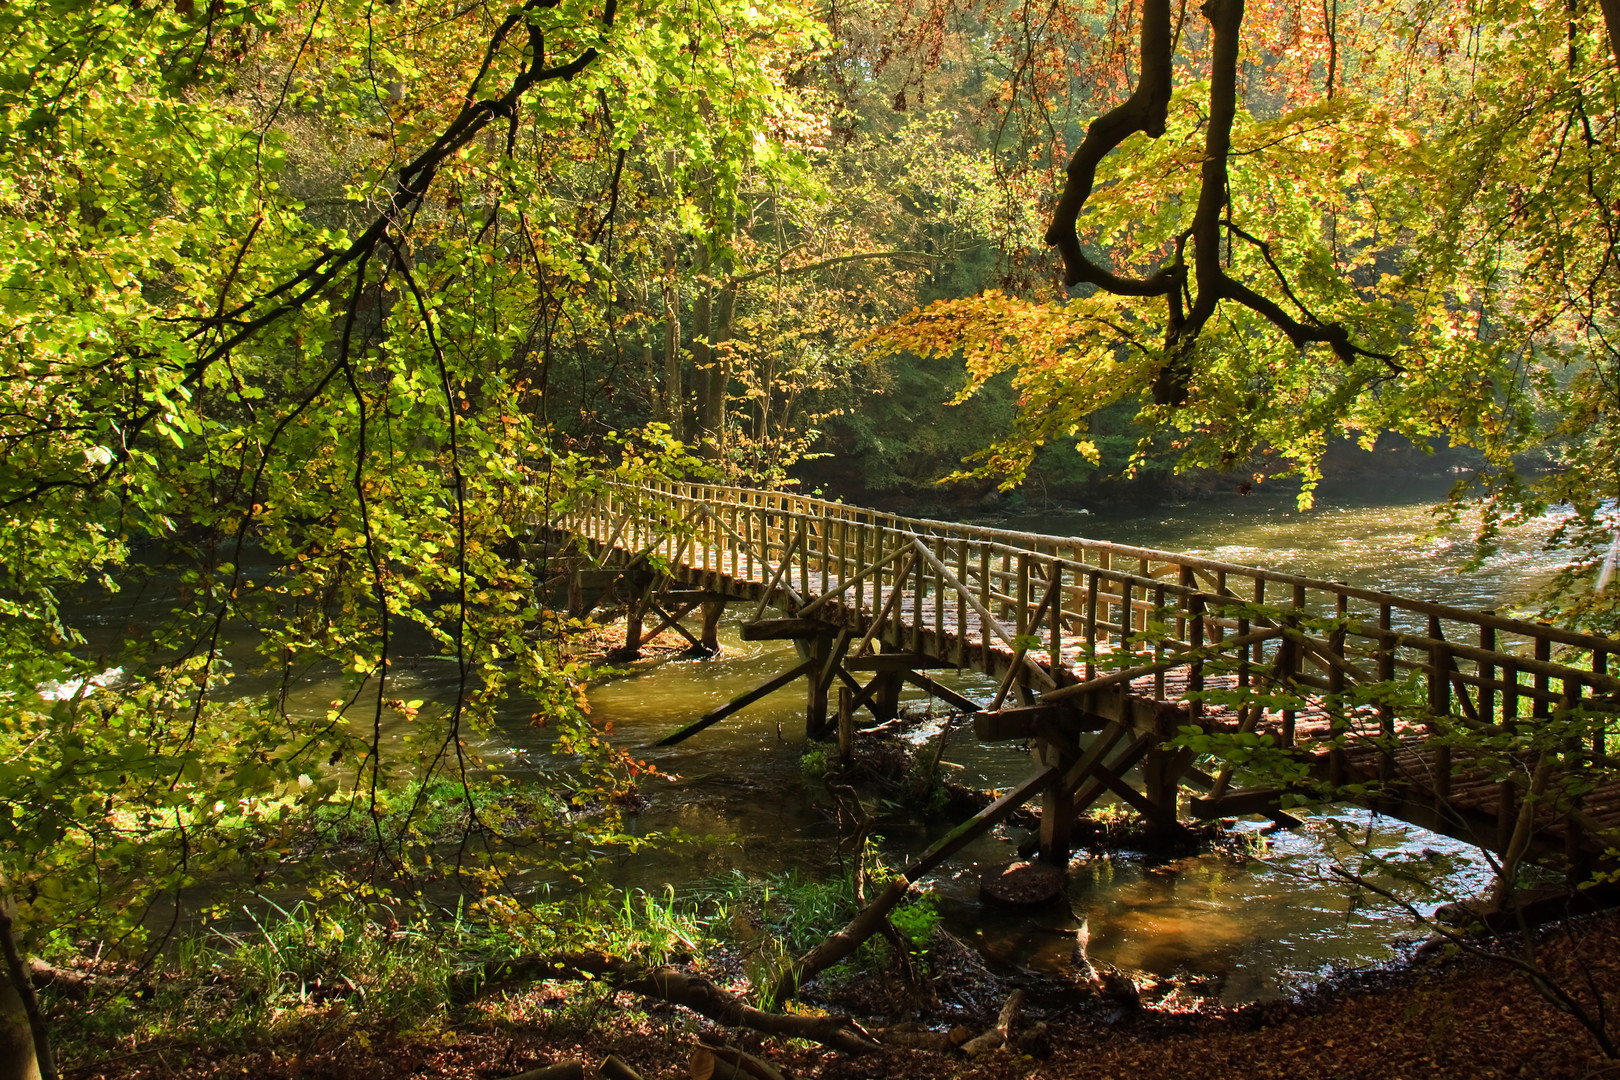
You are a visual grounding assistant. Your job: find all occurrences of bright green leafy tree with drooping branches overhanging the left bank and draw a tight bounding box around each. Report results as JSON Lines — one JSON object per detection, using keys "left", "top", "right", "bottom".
{"left": 0, "top": 0, "right": 816, "bottom": 1074}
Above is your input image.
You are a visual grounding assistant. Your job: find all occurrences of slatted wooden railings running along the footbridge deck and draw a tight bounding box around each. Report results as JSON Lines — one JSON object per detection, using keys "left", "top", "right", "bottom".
{"left": 551, "top": 483, "right": 1620, "bottom": 761}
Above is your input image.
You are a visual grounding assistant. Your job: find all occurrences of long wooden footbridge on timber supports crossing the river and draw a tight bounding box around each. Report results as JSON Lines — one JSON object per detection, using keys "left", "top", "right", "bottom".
{"left": 531, "top": 483, "right": 1620, "bottom": 893}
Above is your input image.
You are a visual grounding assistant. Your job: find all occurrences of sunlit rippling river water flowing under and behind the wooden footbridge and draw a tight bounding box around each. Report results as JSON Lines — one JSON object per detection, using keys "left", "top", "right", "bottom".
{"left": 528, "top": 483, "right": 1558, "bottom": 1001}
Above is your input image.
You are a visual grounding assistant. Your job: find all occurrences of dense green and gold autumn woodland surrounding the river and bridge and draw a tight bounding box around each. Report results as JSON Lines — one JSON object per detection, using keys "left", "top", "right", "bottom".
{"left": 0, "top": 0, "right": 1620, "bottom": 1075}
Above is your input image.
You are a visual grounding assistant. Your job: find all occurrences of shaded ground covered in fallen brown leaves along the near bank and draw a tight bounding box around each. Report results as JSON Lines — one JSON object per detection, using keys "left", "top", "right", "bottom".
{"left": 62, "top": 913, "right": 1620, "bottom": 1080}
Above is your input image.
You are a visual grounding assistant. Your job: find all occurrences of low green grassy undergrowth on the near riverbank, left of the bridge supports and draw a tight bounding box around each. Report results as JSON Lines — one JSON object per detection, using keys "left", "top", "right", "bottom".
{"left": 45, "top": 873, "right": 938, "bottom": 1067}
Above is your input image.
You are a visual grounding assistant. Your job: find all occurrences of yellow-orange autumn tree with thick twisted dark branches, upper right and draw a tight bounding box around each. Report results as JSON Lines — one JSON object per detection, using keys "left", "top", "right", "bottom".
{"left": 873, "top": 0, "right": 1620, "bottom": 634}
